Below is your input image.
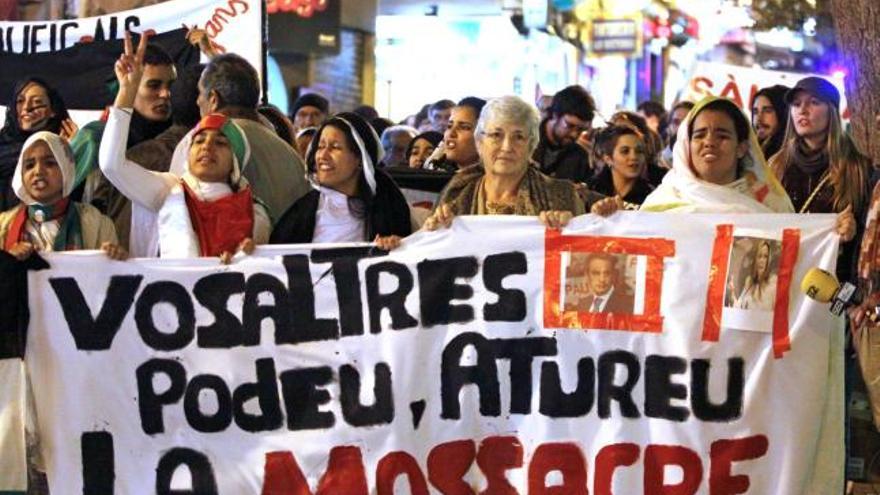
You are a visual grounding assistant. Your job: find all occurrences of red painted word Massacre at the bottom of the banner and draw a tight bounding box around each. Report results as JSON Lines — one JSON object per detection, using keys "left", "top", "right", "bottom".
{"left": 261, "top": 435, "right": 769, "bottom": 495}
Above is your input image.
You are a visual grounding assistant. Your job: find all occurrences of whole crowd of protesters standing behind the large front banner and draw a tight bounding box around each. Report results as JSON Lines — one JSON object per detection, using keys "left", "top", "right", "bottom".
{"left": 0, "top": 29, "right": 880, "bottom": 494}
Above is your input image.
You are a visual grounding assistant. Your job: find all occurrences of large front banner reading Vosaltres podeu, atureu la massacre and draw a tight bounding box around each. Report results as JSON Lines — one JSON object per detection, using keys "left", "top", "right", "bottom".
{"left": 26, "top": 213, "right": 843, "bottom": 495}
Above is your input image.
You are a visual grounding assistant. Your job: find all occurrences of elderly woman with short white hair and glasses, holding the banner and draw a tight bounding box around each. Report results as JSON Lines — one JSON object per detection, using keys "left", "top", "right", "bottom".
{"left": 424, "top": 96, "right": 585, "bottom": 230}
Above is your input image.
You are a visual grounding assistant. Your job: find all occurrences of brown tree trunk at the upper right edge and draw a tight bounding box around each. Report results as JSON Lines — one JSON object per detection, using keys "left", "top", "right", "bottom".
{"left": 831, "top": 0, "right": 880, "bottom": 165}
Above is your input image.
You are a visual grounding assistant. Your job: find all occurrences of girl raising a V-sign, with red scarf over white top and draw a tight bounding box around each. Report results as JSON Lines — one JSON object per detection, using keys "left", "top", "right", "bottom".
{"left": 99, "top": 33, "right": 271, "bottom": 263}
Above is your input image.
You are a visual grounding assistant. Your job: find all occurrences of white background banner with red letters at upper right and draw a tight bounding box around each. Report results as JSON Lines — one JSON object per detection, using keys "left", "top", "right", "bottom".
{"left": 679, "top": 62, "right": 849, "bottom": 119}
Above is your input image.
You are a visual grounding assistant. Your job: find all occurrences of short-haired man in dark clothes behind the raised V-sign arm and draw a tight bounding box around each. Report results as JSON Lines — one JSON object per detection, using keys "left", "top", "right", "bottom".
{"left": 70, "top": 44, "right": 177, "bottom": 204}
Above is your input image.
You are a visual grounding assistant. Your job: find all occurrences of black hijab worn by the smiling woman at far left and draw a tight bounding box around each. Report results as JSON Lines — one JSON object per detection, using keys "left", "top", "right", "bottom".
{"left": 0, "top": 77, "right": 70, "bottom": 211}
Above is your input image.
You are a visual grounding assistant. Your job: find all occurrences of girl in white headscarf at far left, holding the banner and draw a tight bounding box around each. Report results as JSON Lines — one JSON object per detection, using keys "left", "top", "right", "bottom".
{"left": 0, "top": 131, "right": 126, "bottom": 259}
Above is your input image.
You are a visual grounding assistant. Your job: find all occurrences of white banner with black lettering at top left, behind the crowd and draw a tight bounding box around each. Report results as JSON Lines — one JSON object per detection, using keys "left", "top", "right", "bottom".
{"left": 0, "top": 0, "right": 264, "bottom": 125}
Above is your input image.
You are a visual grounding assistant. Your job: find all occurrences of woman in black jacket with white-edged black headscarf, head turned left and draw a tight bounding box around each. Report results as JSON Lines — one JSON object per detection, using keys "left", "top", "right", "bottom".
{"left": 269, "top": 113, "right": 412, "bottom": 247}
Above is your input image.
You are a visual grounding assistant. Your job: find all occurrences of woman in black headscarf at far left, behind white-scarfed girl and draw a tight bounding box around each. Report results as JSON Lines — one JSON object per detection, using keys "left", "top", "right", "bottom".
{"left": 0, "top": 77, "right": 77, "bottom": 211}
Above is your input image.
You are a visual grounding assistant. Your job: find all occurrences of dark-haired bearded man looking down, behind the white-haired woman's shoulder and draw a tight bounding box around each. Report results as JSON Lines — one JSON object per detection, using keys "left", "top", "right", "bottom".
{"left": 532, "top": 86, "right": 596, "bottom": 182}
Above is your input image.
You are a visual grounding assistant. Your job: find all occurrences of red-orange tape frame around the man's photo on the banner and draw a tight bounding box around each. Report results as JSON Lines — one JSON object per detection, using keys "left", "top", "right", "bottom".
{"left": 544, "top": 229, "right": 675, "bottom": 333}
